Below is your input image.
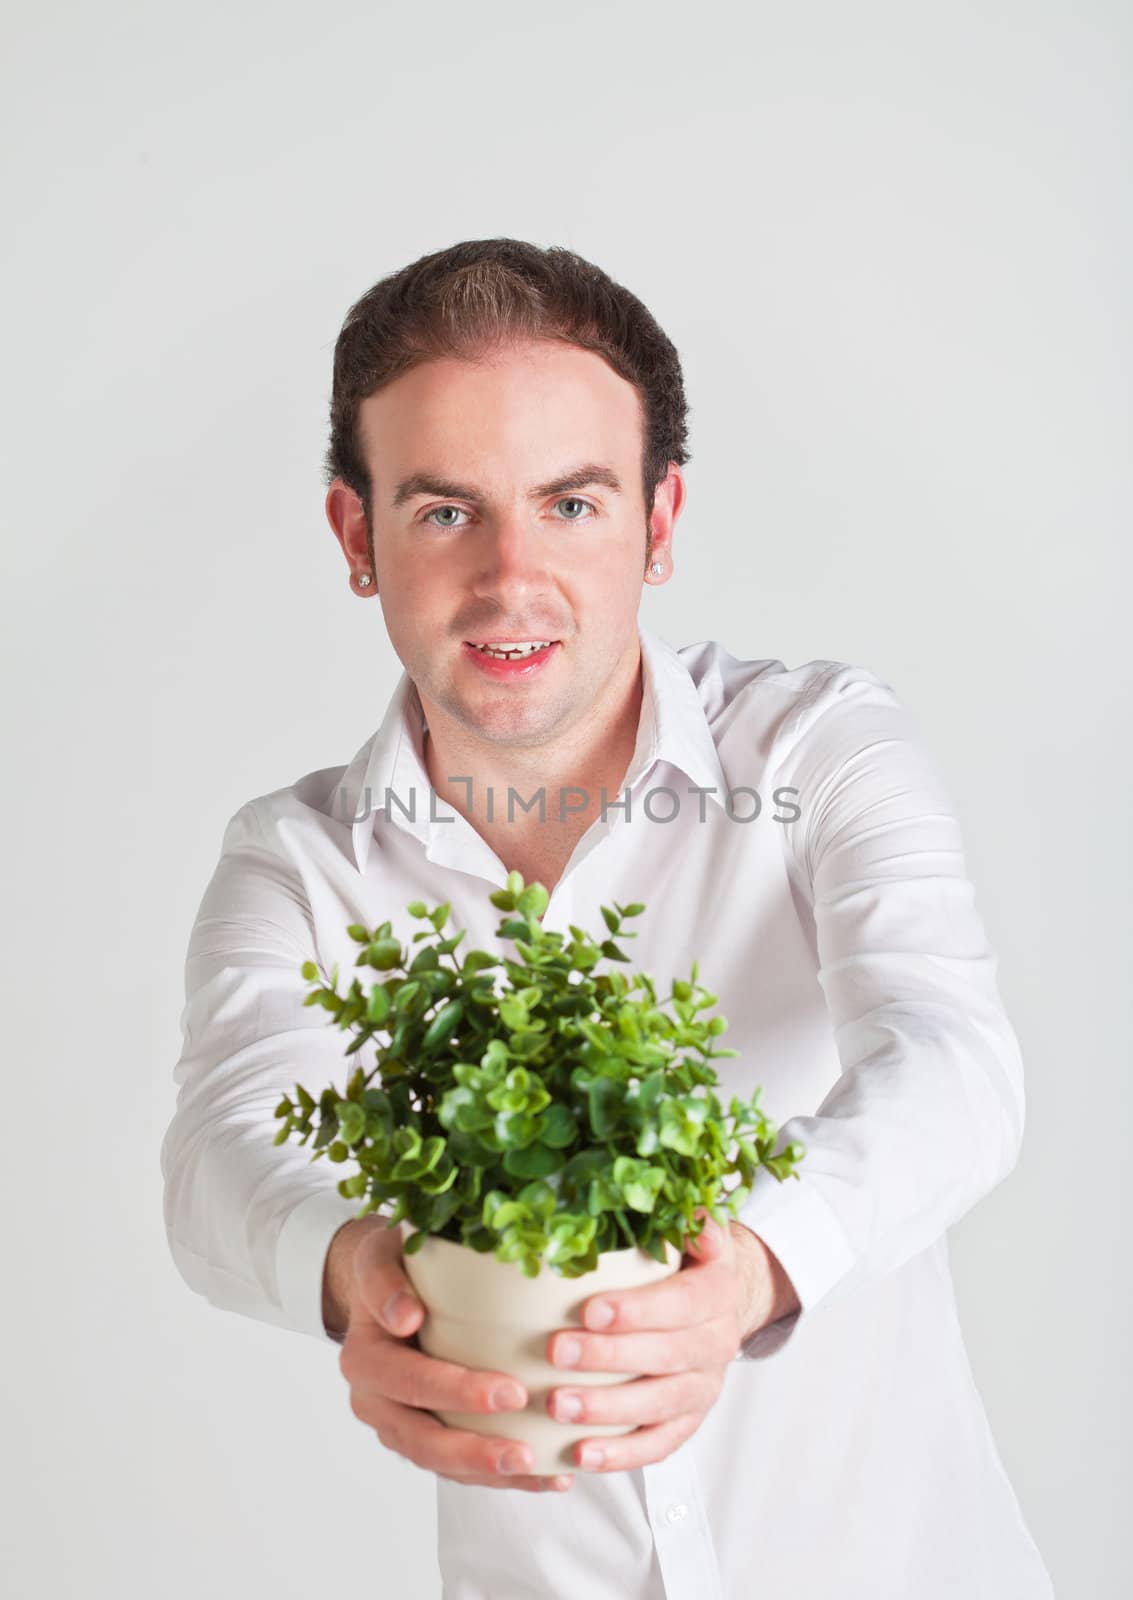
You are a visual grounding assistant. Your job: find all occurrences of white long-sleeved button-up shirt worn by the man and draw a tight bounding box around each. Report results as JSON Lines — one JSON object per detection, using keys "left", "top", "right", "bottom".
{"left": 162, "top": 624, "right": 1053, "bottom": 1600}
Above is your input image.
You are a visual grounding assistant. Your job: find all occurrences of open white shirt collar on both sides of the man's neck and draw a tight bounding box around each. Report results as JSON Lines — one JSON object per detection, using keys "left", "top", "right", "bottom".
{"left": 333, "top": 621, "right": 727, "bottom": 872}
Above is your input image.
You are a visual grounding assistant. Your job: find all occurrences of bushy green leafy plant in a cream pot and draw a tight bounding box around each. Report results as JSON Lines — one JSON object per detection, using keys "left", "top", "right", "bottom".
{"left": 275, "top": 872, "right": 805, "bottom": 1474}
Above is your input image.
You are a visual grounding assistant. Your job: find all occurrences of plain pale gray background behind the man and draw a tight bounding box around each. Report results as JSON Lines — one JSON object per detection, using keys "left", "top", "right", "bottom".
{"left": 0, "top": 0, "right": 1133, "bottom": 1600}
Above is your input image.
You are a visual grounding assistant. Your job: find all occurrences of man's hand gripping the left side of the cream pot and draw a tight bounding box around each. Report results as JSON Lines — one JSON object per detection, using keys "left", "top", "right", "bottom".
{"left": 338, "top": 1222, "right": 575, "bottom": 1491}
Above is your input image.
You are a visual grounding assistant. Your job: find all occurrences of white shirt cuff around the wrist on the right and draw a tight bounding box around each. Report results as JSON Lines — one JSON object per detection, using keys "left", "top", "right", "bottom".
{"left": 735, "top": 1168, "right": 856, "bottom": 1362}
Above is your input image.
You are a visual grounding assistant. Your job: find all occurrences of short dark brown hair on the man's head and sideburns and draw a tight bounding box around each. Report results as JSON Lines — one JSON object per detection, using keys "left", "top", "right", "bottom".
{"left": 323, "top": 238, "right": 690, "bottom": 562}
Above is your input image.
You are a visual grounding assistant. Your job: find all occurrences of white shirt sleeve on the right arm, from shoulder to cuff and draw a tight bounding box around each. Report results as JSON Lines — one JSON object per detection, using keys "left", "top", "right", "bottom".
{"left": 736, "top": 662, "right": 1024, "bottom": 1360}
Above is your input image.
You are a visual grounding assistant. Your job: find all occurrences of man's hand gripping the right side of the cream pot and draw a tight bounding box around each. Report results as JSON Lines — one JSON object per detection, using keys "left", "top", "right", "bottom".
{"left": 547, "top": 1211, "right": 799, "bottom": 1472}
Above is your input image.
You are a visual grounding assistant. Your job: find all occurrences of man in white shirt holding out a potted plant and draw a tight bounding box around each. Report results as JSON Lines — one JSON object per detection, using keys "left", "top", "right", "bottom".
{"left": 163, "top": 240, "right": 1051, "bottom": 1600}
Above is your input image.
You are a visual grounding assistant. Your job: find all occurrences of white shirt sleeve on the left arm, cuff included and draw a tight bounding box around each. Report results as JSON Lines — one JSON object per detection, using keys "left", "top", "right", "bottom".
{"left": 162, "top": 800, "right": 374, "bottom": 1342}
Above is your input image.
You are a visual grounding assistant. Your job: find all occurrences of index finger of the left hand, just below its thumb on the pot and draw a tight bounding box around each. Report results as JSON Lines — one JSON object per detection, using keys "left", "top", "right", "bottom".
{"left": 339, "top": 1328, "right": 528, "bottom": 1411}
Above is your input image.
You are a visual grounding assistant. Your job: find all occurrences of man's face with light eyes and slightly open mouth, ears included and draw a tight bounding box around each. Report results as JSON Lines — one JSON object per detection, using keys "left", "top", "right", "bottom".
{"left": 328, "top": 341, "right": 683, "bottom": 747}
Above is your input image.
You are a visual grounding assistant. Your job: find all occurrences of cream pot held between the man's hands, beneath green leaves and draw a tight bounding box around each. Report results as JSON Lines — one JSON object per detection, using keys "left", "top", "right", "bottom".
{"left": 402, "top": 1222, "right": 682, "bottom": 1475}
